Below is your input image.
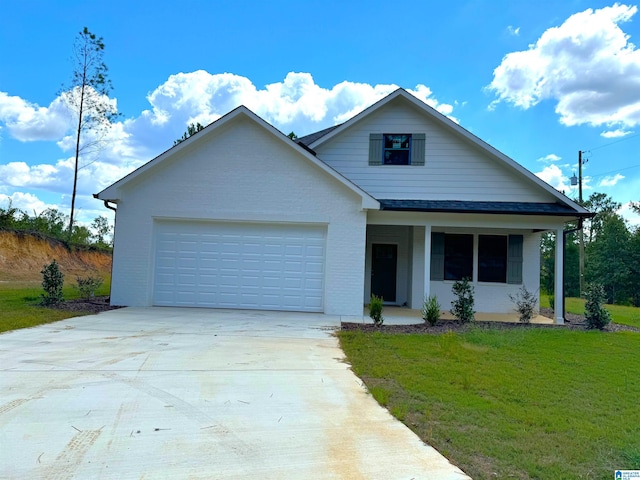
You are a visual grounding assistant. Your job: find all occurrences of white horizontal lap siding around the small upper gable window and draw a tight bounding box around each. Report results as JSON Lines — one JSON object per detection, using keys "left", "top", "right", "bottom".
{"left": 316, "top": 102, "right": 556, "bottom": 202}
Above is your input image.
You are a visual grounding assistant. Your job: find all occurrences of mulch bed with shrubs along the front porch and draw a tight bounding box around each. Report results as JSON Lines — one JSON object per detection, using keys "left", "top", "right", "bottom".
{"left": 341, "top": 308, "right": 640, "bottom": 335}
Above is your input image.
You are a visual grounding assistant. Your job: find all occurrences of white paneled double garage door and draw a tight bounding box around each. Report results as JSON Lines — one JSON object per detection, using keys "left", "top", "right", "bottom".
{"left": 153, "top": 222, "right": 326, "bottom": 312}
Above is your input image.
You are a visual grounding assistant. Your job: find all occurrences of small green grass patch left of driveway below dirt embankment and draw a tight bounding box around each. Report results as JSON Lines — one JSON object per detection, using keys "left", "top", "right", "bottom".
{"left": 0, "top": 278, "right": 111, "bottom": 332}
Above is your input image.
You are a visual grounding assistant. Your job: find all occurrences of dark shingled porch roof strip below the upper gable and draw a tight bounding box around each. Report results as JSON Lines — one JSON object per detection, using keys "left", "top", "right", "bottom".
{"left": 378, "top": 199, "right": 591, "bottom": 217}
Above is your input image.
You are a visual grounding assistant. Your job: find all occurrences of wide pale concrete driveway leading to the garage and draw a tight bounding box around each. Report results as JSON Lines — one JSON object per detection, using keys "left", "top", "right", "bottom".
{"left": 0, "top": 308, "right": 468, "bottom": 479}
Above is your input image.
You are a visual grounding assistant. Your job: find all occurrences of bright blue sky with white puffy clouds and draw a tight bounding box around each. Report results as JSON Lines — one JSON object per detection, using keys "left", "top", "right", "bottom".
{"left": 0, "top": 0, "right": 640, "bottom": 228}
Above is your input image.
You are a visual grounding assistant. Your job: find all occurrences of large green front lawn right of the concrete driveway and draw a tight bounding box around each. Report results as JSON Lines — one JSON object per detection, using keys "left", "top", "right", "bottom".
{"left": 339, "top": 328, "right": 640, "bottom": 479}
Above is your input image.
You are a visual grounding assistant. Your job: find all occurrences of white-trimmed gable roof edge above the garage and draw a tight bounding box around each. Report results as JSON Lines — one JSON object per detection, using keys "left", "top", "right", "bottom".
{"left": 93, "top": 105, "right": 380, "bottom": 210}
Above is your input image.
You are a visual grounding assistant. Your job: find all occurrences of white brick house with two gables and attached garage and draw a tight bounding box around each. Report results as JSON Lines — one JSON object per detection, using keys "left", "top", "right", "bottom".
{"left": 95, "top": 89, "right": 588, "bottom": 321}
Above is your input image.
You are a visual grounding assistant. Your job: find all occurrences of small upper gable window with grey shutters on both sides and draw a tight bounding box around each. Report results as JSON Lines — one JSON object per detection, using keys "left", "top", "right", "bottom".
{"left": 369, "top": 133, "right": 425, "bottom": 166}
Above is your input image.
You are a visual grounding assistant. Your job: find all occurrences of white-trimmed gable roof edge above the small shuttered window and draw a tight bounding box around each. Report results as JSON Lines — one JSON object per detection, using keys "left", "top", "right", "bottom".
{"left": 298, "top": 88, "right": 589, "bottom": 216}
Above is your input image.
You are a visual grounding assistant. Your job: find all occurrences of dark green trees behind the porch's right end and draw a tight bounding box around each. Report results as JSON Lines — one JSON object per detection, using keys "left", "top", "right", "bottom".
{"left": 540, "top": 193, "right": 640, "bottom": 307}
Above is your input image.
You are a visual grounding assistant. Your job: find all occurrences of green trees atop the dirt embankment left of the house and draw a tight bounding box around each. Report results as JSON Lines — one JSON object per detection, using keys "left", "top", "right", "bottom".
{"left": 0, "top": 202, "right": 113, "bottom": 249}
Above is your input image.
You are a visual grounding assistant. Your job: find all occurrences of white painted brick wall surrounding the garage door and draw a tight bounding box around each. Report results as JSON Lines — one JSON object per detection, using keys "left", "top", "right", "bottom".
{"left": 112, "top": 117, "right": 366, "bottom": 315}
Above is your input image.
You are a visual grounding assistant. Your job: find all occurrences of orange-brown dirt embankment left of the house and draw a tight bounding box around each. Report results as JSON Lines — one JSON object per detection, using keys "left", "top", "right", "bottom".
{"left": 0, "top": 230, "right": 111, "bottom": 282}
